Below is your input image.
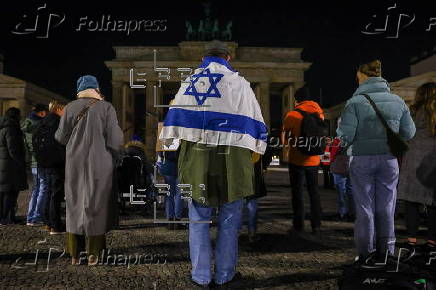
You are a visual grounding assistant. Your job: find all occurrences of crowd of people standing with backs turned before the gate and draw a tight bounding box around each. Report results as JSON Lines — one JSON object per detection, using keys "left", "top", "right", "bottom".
{"left": 0, "top": 41, "right": 436, "bottom": 288}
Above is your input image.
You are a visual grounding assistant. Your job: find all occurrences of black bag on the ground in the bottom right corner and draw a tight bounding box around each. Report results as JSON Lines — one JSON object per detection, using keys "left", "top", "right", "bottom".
{"left": 339, "top": 267, "right": 436, "bottom": 290}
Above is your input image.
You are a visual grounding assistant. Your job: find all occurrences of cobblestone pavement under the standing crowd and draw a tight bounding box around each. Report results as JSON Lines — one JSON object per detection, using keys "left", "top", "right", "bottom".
{"left": 0, "top": 168, "right": 416, "bottom": 290}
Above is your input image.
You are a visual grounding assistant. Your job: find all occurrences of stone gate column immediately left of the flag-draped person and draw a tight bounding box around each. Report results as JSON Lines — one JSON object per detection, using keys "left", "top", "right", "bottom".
{"left": 145, "top": 81, "right": 159, "bottom": 162}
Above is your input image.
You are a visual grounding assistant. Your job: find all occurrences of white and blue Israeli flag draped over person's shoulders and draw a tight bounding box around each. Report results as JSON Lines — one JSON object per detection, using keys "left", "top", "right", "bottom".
{"left": 159, "top": 57, "right": 268, "bottom": 154}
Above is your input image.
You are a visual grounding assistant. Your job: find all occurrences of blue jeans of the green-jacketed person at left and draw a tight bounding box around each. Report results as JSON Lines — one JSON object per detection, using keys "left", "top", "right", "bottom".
{"left": 27, "top": 168, "right": 48, "bottom": 223}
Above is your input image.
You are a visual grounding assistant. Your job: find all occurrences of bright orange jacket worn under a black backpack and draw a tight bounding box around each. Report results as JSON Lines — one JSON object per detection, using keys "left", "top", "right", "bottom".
{"left": 283, "top": 101, "right": 324, "bottom": 166}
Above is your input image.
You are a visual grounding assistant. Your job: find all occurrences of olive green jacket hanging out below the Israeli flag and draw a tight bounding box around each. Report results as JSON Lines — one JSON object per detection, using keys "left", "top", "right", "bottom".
{"left": 178, "top": 140, "right": 254, "bottom": 207}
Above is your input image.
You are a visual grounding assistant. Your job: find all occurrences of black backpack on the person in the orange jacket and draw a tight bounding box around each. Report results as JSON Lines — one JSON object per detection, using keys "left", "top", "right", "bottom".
{"left": 295, "top": 109, "right": 328, "bottom": 156}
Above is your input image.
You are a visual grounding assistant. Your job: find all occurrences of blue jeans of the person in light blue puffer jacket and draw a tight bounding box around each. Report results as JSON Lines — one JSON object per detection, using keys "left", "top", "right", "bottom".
{"left": 350, "top": 154, "right": 399, "bottom": 256}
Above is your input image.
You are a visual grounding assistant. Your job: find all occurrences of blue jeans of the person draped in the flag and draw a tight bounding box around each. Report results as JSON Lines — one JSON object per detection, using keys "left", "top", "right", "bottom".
{"left": 189, "top": 199, "right": 243, "bottom": 285}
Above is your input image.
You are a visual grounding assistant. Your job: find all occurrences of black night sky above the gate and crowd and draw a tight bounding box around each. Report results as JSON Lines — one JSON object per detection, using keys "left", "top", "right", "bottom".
{"left": 0, "top": 0, "right": 436, "bottom": 107}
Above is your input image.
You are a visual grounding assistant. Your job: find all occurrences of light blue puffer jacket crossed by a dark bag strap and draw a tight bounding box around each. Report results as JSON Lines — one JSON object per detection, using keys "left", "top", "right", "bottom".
{"left": 336, "top": 77, "right": 416, "bottom": 156}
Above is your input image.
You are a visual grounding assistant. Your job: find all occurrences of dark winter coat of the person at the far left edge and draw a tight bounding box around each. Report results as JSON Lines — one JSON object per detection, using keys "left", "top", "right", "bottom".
{"left": 0, "top": 117, "right": 27, "bottom": 192}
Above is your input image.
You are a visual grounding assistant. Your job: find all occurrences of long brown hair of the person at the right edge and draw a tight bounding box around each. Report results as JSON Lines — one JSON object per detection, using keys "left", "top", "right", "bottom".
{"left": 410, "top": 82, "right": 436, "bottom": 136}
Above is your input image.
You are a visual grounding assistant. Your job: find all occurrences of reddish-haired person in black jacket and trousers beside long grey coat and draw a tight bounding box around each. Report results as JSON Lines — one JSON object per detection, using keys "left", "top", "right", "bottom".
{"left": 32, "top": 101, "right": 65, "bottom": 235}
